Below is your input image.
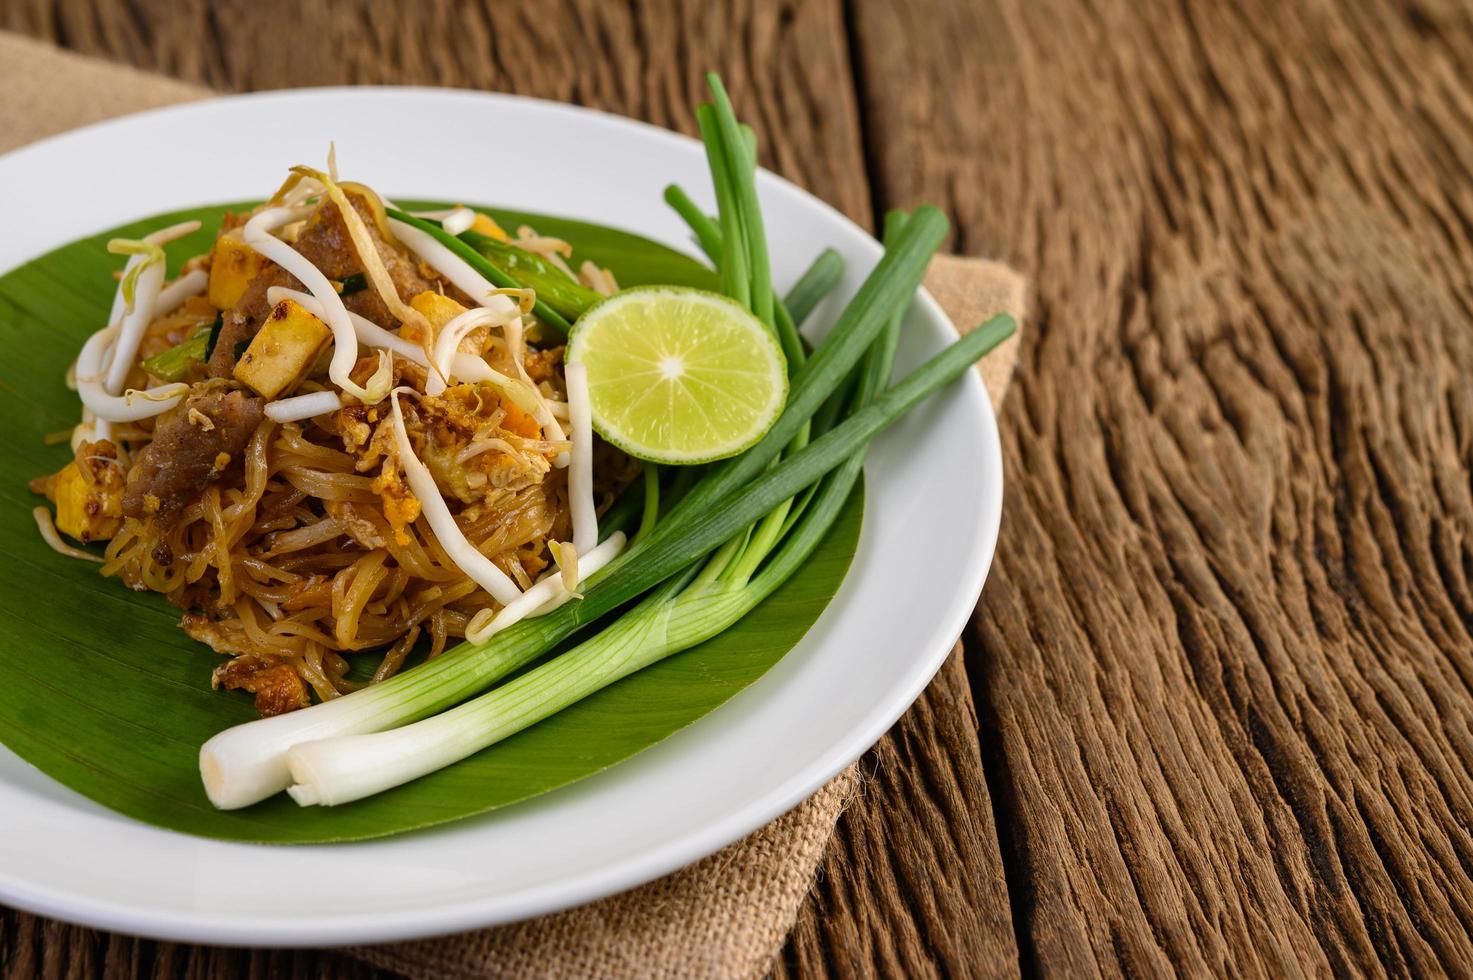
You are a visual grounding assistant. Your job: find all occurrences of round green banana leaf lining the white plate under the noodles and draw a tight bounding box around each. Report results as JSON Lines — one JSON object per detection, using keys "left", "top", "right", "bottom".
{"left": 0, "top": 205, "right": 862, "bottom": 843}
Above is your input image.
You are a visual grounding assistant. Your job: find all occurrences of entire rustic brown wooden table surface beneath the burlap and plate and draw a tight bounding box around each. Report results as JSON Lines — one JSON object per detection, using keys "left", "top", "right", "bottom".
{"left": 0, "top": 0, "right": 1473, "bottom": 977}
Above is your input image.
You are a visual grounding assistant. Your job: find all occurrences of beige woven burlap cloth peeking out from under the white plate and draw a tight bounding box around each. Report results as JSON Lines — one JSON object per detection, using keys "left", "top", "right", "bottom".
{"left": 0, "top": 32, "right": 1024, "bottom": 979}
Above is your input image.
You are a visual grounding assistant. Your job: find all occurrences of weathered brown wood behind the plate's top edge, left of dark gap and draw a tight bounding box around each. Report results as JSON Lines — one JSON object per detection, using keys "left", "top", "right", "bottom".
{"left": 0, "top": 0, "right": 869, "bottom": 223}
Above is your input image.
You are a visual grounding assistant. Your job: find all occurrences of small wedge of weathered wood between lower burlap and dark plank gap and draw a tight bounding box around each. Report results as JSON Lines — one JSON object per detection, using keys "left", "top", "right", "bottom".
{"left": 778, "top": 644, "right": 1018, "bottom": 977}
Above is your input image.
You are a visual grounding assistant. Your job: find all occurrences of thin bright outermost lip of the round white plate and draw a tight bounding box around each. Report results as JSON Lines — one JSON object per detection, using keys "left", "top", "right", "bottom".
{"left": 0, "top": 85, "right": 1006, "bottom": 946}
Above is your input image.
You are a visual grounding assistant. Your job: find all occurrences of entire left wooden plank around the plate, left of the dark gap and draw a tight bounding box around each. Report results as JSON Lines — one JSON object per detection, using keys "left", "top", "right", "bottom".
{"left": 0, "top": 0, "right": 1016, "bottom": 979}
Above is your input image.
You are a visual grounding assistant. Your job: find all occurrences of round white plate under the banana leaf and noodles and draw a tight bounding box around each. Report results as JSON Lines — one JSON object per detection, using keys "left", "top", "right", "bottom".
{"left": 0, "top": 88, "right": 1002, "bottom": 946}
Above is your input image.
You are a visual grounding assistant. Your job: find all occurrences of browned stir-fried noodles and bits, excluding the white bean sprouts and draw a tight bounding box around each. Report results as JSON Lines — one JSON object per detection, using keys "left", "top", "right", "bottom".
{"left": 34, "top": 173, "right": 636, "bottom": 715}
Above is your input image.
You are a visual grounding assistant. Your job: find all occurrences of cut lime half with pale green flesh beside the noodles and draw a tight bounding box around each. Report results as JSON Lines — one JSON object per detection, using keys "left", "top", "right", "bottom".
{"left": 567, "top": 286, "right": 788, "bottom": 464}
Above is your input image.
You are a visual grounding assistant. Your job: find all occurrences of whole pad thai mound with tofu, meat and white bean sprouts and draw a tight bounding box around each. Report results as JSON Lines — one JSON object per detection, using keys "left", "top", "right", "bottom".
{"left": 32, "top": 164, "right": 638, "bottom": 715}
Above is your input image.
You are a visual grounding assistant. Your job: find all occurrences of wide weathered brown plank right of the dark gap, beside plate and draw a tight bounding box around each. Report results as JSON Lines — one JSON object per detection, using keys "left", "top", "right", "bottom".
{"left": 856, "top": 0, "right": 1473, "bottom": 976}
